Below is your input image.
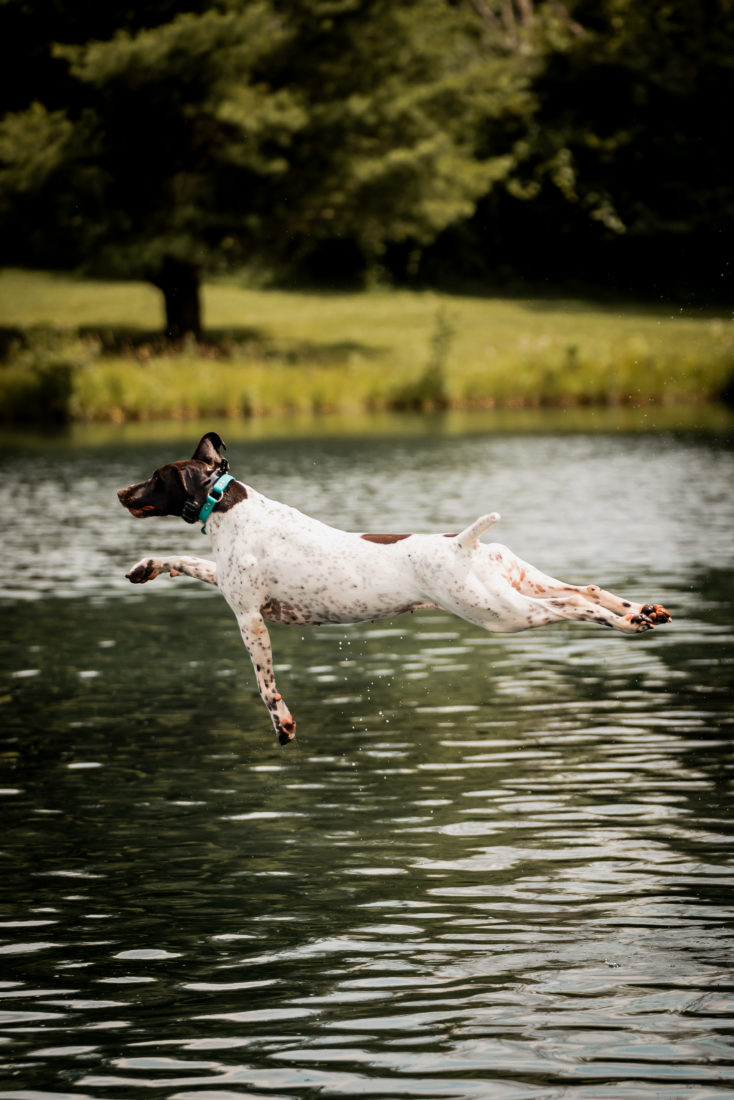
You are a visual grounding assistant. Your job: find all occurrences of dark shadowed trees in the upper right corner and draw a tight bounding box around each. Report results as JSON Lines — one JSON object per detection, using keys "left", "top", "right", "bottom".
{"left": 484, "top": 0, "right": 734, "bottom": 296}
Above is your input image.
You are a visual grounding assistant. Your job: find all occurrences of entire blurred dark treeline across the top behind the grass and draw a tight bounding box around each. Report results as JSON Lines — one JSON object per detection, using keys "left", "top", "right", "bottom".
{"left": 0, "top": 0, "right": 734, "bottom": 337}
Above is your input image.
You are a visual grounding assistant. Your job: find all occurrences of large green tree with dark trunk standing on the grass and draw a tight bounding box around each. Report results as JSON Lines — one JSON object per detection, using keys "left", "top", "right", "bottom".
{"left": 0, "top": 0, "right": 505, "bottom": 339}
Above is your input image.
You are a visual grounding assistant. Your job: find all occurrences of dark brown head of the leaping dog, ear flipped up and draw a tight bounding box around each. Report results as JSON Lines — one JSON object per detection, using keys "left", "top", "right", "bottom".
{"left": 118, "top": 431, "right": 229, "bottom": 524}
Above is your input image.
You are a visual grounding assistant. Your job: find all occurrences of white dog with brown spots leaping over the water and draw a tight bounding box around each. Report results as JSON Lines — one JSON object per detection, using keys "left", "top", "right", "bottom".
{"left": 118, "top": 431, "right": 670, "bottom": 745}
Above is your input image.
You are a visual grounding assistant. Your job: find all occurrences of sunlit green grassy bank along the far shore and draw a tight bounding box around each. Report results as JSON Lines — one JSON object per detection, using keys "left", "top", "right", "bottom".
{"left": 0, "top": 271, "right": 734, "bottom": 422}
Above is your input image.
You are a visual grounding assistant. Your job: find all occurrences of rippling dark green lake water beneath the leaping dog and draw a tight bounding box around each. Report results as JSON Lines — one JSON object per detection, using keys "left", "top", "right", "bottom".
{"left": 0, "top": 418, "right": 734, "bottom": 1100}
